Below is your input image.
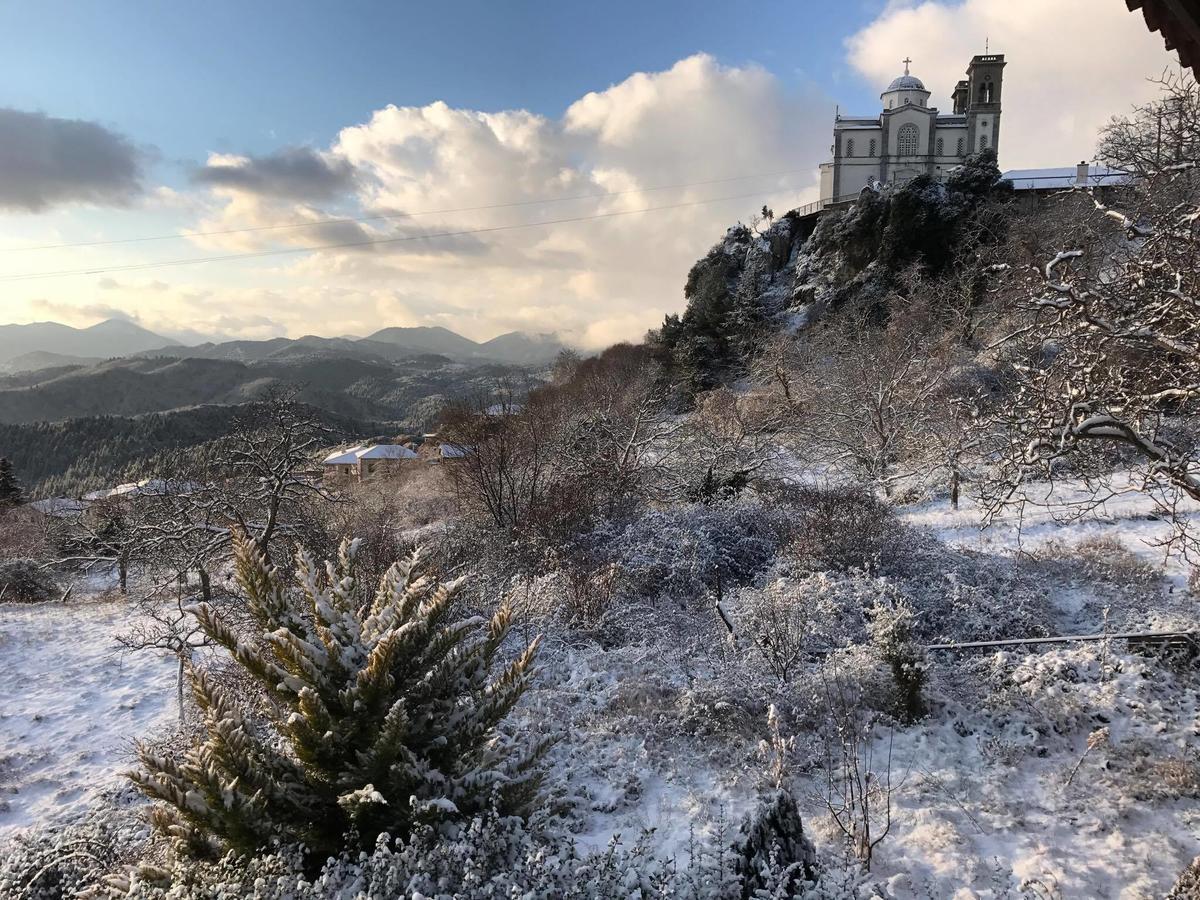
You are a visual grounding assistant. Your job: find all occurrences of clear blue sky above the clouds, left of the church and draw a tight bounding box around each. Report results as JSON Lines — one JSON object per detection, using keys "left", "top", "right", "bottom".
{"left": 0, "top": 0, "right": 883, "bottom": 167}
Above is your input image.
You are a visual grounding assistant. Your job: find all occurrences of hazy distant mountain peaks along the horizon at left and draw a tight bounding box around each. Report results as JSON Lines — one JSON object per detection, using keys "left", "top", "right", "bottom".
{"left": 0, "top": 319, "right": 563, "bottom": 373}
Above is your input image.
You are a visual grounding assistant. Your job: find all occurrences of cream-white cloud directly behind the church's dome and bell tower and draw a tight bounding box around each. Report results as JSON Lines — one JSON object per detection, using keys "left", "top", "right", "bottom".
{"left": 847, "top": 0, "right": 1176, "bottom": 168}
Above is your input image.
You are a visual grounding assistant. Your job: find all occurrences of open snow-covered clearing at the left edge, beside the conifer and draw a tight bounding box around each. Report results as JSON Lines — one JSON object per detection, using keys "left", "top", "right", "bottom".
{"left": 0, "top": 600, "right": 176, "bottom": 840}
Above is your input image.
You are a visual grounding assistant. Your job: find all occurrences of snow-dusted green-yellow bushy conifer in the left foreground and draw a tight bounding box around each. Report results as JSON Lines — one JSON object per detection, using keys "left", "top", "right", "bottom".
{"left": 130, "top": 535, "right": 548, "bottom": 863}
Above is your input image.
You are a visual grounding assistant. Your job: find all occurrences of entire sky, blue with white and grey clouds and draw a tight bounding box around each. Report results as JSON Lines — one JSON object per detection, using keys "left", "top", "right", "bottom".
{"left": 0, "top": 0, "right": 1174, "bottom": 349}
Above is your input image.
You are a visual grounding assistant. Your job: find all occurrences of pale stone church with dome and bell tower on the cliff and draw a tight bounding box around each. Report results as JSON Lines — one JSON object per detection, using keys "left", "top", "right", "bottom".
{"left": 821, "top": 54, "right": 1004, "bottom": 206}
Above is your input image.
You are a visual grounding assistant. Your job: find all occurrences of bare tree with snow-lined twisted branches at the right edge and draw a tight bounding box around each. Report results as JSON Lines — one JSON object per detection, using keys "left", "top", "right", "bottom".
{"left": 985, "top": 170, "right": 1200, "bottom": 550}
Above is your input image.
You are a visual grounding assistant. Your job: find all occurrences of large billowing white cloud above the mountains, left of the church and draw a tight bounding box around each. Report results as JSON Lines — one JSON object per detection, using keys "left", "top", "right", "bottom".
{"left": 175, "top": 55, "right": 833, "bottom": 347}
